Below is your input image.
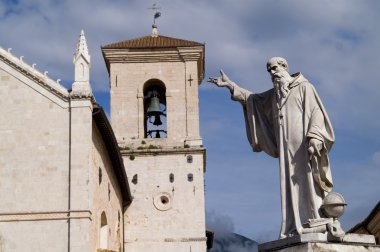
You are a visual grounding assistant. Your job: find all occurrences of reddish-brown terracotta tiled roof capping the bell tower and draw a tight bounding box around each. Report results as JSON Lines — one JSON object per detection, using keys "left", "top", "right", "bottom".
{"left": 102, "top": 36, "right": 203, "bottom": 49}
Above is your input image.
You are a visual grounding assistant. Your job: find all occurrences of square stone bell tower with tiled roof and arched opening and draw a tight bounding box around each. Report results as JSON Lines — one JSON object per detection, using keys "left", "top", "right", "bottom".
{"left": 102, "top": 25, "right": 206, "bottom": 252}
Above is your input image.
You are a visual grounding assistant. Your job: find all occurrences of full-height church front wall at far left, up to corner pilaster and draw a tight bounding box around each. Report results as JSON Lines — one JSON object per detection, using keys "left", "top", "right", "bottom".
{"left": 0, "top": 61, "right": 69, "bottom": 252}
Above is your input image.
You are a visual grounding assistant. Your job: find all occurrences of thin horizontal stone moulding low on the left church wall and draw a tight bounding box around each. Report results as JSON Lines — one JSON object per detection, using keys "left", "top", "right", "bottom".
{"left": 0, "top": 210, "right": 92, "bottom": 222}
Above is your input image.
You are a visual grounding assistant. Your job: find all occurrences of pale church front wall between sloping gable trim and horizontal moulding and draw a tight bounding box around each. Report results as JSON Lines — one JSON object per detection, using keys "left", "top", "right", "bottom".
{"left": 0, "top": 70, "right": 68, "bottom": 212}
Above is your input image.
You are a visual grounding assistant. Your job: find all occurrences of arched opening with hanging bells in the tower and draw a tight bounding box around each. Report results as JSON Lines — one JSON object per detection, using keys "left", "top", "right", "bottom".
{"left": 144, "top": 79, "right": 167, "bottom": 138}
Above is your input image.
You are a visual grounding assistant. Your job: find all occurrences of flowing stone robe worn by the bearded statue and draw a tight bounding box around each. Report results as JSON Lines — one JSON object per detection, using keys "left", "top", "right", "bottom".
{"left": 231, "top": 73, "right": 334, "bottom": 238}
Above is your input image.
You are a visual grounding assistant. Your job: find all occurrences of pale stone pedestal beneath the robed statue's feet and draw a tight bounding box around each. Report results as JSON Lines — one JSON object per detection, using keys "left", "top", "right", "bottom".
{"left": 259, "top": 233, "right": 380, "bottom": 252}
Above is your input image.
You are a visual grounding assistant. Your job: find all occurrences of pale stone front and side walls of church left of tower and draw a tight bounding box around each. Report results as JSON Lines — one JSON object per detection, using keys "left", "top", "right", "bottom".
{"left": 0, "top": 54, "right": 123, "bottom": 252}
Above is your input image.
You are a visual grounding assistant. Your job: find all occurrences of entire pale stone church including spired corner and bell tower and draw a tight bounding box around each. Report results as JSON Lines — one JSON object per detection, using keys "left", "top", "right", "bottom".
{"left": 0, "top": 27, "right": 207, "bottom": 252}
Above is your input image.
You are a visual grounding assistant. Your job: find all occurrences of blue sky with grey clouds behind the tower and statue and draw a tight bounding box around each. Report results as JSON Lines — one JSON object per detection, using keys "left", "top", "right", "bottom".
{"left": 0, "top": 0, "right": 380, "bottom": 242}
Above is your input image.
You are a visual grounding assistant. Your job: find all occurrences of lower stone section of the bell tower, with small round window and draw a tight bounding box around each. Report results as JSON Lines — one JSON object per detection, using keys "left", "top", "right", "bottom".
{"left": 124, "top": 149, "right": 206, "bottom": 251}
